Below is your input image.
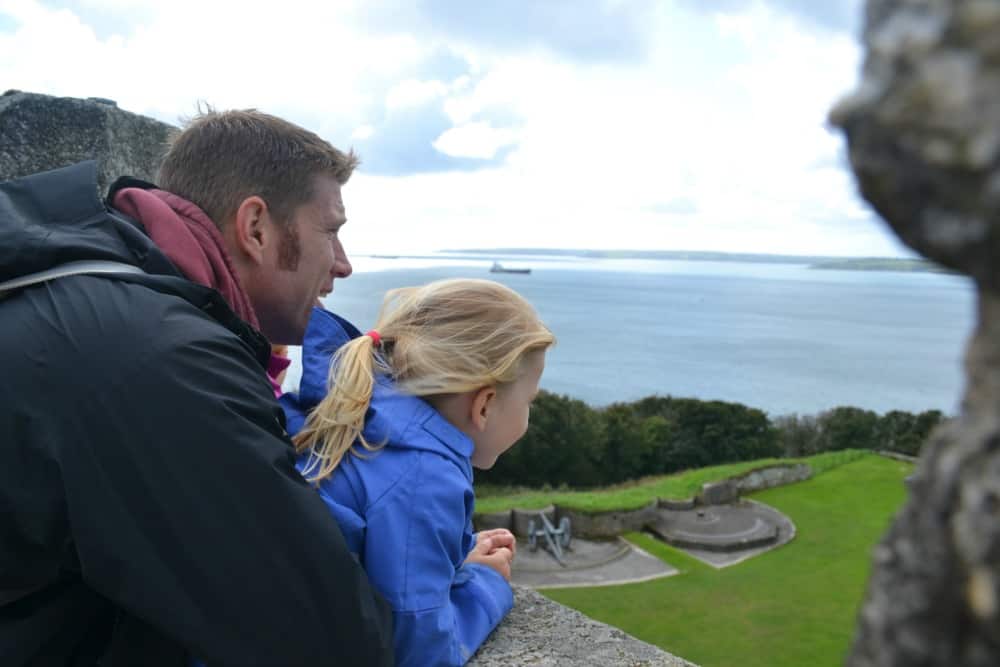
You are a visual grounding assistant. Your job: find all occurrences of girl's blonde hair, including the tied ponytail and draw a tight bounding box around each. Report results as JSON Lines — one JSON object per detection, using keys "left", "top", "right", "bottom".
{"left": 294, "top": 279, "right": 555, "bottom": 481}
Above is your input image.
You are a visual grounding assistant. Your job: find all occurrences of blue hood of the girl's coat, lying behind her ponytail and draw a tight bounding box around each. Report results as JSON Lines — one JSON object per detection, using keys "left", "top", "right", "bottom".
{"left": 279, "top": 308, "right": 472, "bottom": 468}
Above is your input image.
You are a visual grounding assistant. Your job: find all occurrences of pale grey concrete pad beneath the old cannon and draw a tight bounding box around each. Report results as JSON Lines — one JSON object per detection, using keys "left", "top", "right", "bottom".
{"left": 511, "top": 538, "right": 677, "bottom": 588}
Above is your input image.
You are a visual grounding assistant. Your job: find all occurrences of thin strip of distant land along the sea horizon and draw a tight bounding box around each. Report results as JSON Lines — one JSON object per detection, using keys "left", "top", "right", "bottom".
{"left": 441, "top": 248, "right": 953, "bottom": 273}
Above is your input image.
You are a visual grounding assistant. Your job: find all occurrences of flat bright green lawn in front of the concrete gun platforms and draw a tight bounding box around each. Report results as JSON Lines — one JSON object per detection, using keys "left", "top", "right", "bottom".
{"left": 543, "top": 455, "right": 912, "bottom": 667}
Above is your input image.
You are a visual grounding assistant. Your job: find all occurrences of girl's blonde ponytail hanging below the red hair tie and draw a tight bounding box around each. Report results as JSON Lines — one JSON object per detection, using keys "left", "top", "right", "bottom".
{"left": 292, "top": 335, "right": 381, "bottom": 481}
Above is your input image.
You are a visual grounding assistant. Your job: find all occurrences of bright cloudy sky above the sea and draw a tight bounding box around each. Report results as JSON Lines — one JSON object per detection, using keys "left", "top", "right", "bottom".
{"left": 0, "top": 0, "right": 909, "bottom": 256}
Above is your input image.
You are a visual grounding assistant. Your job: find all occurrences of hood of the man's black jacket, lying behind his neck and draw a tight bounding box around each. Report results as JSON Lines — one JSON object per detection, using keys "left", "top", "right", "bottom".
{"left": 0, "top": 161, "right": 178, "bottom": 282}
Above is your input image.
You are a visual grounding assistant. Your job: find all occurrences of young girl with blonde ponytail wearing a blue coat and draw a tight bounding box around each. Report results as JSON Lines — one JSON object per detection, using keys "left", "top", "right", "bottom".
{"left": 282, "top": 280, "right": 554, "bottom": 665}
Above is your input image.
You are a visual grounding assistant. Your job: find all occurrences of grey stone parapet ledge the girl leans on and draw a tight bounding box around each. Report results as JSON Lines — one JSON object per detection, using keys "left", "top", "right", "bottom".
{"left": 469, "top": 585, "right": 697, "bottom": 667}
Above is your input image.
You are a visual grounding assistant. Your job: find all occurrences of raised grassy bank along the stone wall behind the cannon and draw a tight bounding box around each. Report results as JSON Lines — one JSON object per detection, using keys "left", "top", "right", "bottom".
{"left": 476, "top": 449, "right": 869, "bottom": 513}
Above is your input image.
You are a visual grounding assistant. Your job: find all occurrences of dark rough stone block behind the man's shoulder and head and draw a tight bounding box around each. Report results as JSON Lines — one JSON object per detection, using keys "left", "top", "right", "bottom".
{"left": 0, "top": 90, "right": 176, "bottom": 194}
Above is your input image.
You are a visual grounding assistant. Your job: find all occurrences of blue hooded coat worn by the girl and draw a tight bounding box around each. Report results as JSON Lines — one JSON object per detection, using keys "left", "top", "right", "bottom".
{"left": 280, "top": 308, "right": 514, "bottom": 666}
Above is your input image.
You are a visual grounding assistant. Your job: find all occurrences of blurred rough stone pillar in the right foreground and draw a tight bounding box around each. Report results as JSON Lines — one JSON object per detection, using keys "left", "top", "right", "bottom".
{"left": 831, "top": 0, "right": 1000, "bottom": 667}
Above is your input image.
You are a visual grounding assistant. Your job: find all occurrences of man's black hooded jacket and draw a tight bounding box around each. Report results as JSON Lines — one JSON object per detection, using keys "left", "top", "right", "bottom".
{"left": 0, "top": 163, "right": 392, "bottom": 666}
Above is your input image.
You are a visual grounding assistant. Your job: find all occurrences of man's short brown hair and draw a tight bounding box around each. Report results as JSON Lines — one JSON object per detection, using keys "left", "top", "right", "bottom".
{"left": 158, "top": 108, "right": 358, "bottom": 229}
